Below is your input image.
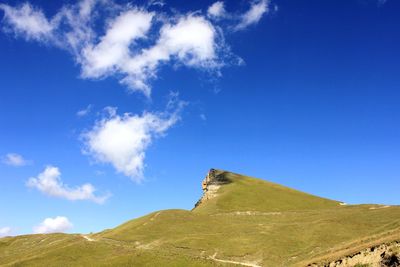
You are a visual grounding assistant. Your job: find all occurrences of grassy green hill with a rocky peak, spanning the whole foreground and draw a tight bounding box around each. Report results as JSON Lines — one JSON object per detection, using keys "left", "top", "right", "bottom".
{"left": 0, "top": 169, "right": 400, "bottom": 267}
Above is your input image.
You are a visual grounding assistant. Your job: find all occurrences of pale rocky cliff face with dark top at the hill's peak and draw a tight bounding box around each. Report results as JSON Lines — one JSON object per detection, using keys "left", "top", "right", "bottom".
{"left": 194, "top": 169, "right": 230, "bottom": 208}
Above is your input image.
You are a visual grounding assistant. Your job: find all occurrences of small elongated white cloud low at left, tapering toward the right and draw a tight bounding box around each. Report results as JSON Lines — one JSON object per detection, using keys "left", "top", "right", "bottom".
{"left": 27, "top": 166, "right": 110, "bottom": 204}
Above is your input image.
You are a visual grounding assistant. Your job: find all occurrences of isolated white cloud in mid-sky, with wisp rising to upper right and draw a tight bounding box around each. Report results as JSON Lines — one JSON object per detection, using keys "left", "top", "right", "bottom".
{"left": 82, "top": 95, "right": 184, "bottom": 182}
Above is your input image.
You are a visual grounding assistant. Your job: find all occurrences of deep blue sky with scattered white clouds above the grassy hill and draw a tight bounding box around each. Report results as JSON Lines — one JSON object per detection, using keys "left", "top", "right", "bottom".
{"left": 0, "top": 0, "right": 400, "bottom": 235}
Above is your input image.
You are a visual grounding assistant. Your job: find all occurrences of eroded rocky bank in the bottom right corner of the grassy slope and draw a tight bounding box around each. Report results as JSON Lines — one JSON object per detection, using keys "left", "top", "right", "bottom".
{"left": 308, "top": 241, "right": 400, "bottom": 267}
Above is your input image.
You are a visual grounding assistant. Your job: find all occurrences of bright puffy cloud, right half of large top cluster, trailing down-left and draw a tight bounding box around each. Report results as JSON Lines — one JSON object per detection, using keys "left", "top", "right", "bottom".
{"left": 121, "top": 15, "right": 218, "bottom": 95}
